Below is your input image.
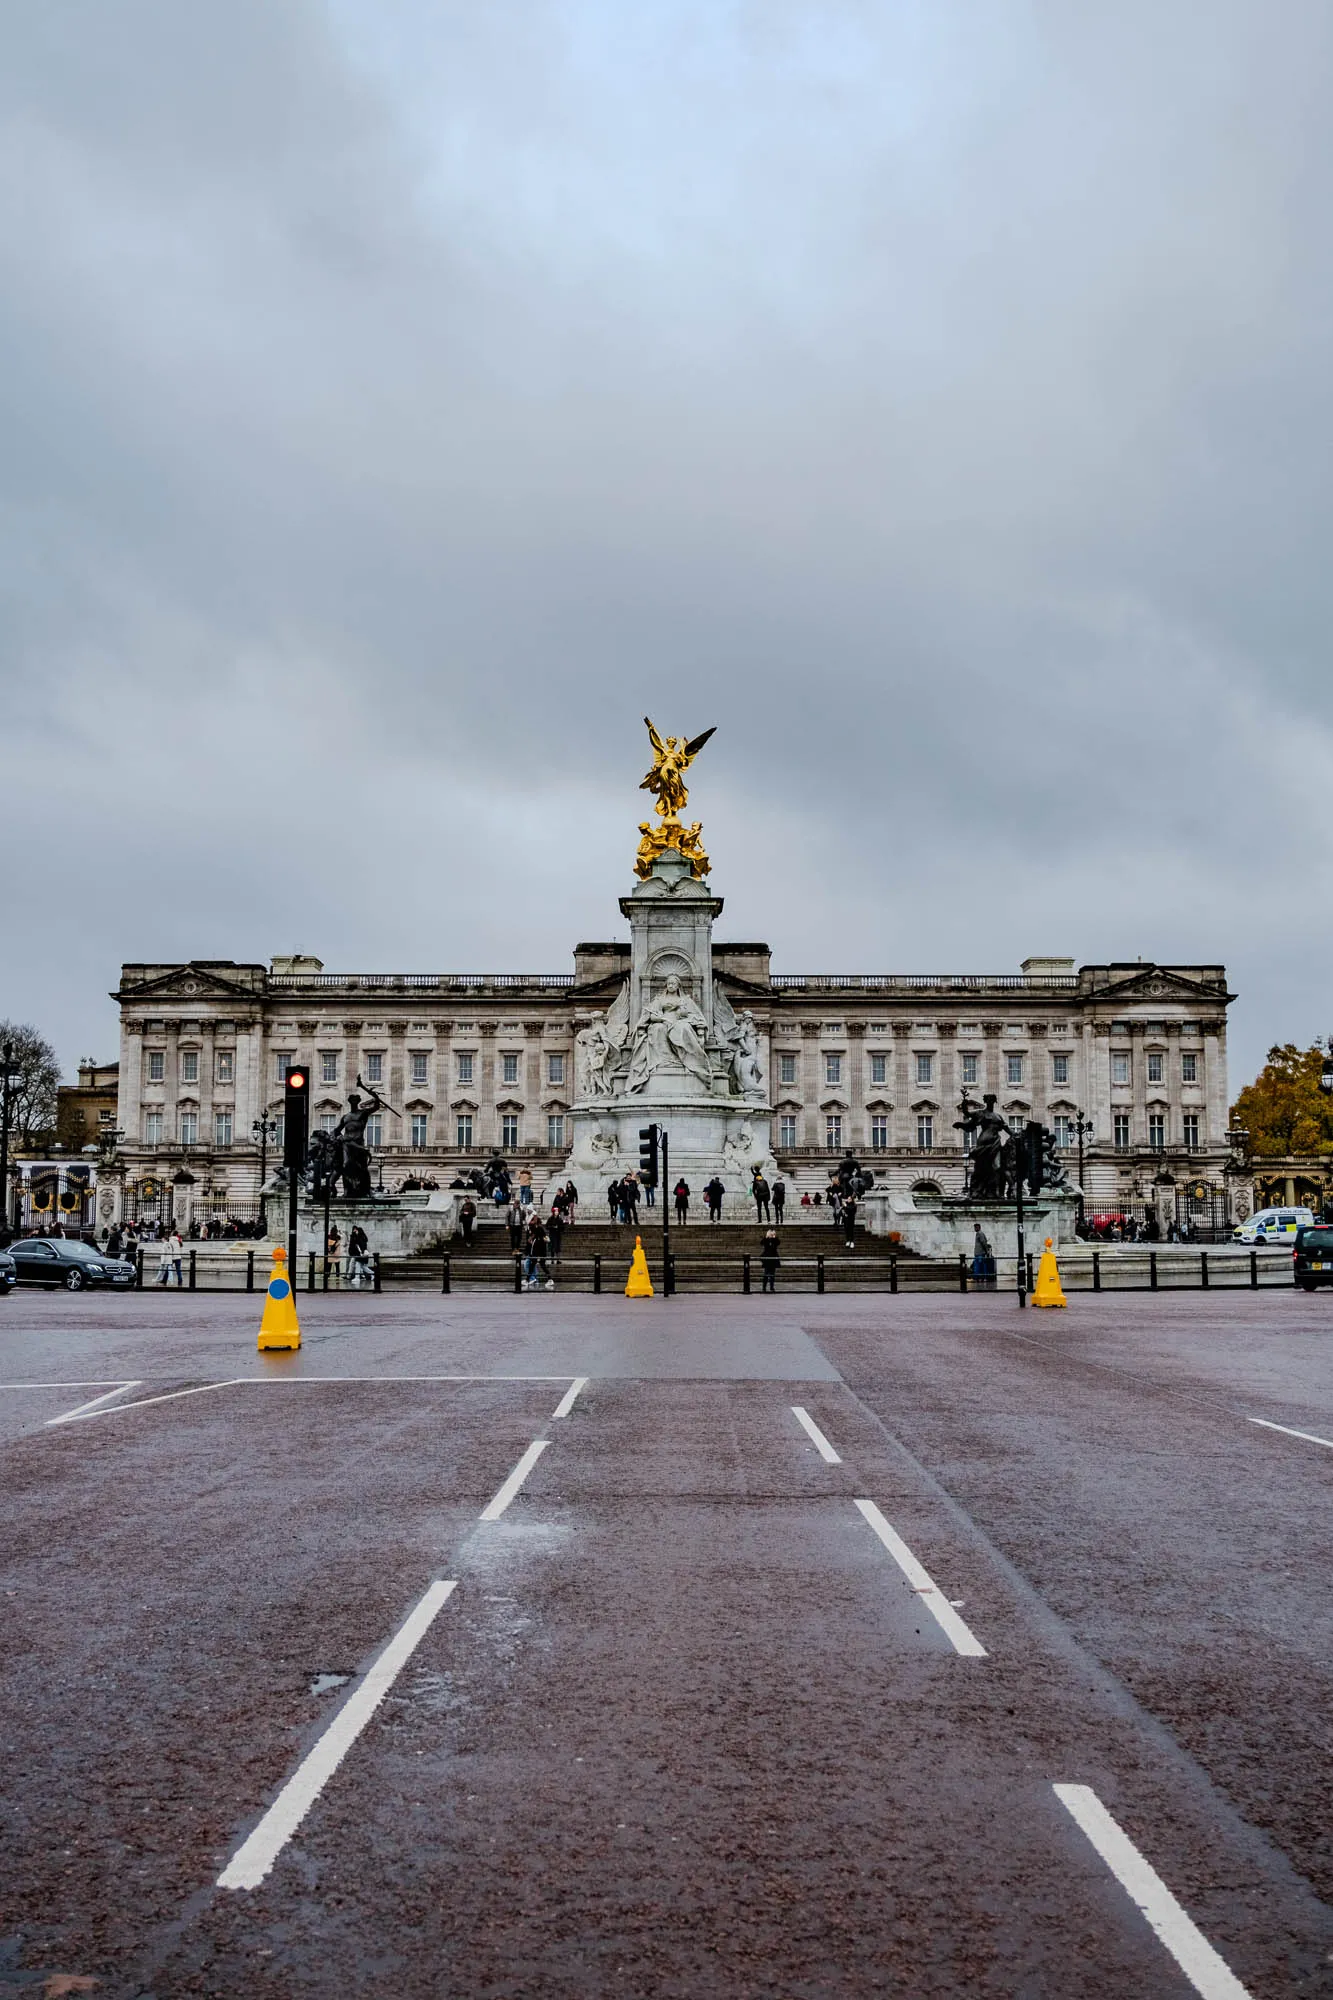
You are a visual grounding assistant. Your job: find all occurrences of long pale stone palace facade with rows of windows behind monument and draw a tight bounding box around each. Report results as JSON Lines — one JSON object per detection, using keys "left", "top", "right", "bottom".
{"left": 102, "top": 942, "right": 1233, "bottom": 1222}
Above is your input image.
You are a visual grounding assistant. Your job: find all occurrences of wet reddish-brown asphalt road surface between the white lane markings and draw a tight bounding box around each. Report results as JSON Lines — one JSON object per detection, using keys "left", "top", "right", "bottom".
{"left": 0, "top": 1294, "right": 1333, "bottom": 2000}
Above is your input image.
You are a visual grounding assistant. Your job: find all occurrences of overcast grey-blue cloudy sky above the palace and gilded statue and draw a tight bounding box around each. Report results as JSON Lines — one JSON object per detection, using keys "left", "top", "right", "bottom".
{"left": 0, "top": 0, "right": 1333, "bottom": 1084}
